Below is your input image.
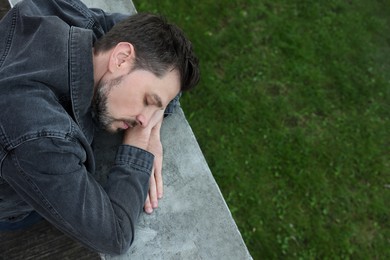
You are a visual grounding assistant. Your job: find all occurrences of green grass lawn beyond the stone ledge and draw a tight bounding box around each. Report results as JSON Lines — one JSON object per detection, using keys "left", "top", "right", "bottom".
{"left": 134, "top": 0, "right": 390, "bottom": 259}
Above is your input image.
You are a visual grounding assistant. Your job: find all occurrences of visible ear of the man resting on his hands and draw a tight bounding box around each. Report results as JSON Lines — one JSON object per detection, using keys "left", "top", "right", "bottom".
{"left": 108, "top": 42, "right": 135, "bottom": 74}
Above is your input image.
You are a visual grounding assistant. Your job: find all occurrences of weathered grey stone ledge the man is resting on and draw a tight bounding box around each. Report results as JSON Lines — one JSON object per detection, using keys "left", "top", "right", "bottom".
{"left": 10, "top": 0, "right": 251, "bottom": 260}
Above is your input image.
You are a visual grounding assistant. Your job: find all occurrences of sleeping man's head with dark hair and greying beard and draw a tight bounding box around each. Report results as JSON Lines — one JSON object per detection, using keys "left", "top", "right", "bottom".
{"left": 93, "top": 14, "right": 199, "bottom": 131}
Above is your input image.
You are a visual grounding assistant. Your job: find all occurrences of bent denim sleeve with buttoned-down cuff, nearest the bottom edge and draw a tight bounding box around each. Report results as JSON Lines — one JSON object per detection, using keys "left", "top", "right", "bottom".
{"left": 2, "top": 137, "right": 153, "bottom": 254}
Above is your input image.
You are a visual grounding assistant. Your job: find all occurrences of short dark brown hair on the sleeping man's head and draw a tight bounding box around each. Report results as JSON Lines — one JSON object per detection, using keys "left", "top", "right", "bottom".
{"left": 94, "top": 13, "right": 200, "bottom": 91}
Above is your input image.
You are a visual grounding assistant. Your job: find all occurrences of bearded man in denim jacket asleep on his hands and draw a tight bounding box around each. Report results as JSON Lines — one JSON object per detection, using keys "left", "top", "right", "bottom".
{"left": 0, "top": 0, "right": 199, "bottom": 254}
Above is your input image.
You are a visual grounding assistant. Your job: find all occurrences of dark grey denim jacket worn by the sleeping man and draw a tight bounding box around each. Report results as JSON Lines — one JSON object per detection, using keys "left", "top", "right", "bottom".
{"left": 0, "top": 0, "right": 173, "bottom": 254}
